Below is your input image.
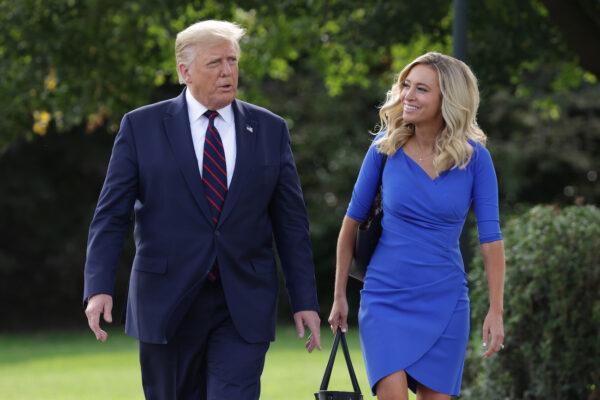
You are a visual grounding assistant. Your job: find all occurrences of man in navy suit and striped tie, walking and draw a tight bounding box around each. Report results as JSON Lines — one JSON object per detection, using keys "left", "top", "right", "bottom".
{"left": 84, "top": 21, "right": 320, "bottom": 400}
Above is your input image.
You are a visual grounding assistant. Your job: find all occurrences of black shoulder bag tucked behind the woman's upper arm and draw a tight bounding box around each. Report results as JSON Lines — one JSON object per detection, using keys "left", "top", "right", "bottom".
{"left": 350, "top": 155, "right": 387, "bottom": 282}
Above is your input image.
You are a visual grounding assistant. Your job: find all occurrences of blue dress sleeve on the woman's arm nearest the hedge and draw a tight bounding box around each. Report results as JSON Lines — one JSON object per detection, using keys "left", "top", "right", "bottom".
{"left": 472, "top": 143, "right": 502, "bottom": 244}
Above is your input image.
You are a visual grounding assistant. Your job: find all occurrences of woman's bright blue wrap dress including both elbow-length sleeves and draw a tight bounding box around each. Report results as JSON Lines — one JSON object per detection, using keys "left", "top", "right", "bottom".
{"left": 346, "top": 137, "right": 502, "bottom": 396}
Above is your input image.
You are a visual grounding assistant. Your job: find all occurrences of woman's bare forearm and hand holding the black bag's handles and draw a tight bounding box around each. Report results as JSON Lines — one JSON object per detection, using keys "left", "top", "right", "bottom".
{"left": 328, "top": 216, "right": 359, "bottom": 333}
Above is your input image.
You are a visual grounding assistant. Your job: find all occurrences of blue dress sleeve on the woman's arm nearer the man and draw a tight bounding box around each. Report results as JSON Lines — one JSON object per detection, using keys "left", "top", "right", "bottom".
{"left": 346, "top": 134, "right": 383, "bottom": 222}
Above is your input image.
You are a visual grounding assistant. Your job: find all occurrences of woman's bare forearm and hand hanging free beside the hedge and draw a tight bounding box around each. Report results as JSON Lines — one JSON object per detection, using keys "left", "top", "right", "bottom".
{"left": 481, "top": 240, "right": 505, "bottom": 357}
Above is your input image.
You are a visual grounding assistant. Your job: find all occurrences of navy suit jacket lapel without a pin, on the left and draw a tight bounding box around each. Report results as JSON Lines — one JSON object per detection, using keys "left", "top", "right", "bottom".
{"left": 163, "top": 90, "right": 212, "bottom": 221}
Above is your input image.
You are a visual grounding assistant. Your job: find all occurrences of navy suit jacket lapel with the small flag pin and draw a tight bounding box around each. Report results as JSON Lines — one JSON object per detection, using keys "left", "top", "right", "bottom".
{"left": 218, "top": 100, "right": 258, "bottom": 226}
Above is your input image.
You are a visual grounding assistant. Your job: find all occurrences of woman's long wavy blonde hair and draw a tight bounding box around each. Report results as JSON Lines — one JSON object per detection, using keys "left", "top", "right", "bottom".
{"left": 376, "top": 52, "right": 487, "bottom": 175}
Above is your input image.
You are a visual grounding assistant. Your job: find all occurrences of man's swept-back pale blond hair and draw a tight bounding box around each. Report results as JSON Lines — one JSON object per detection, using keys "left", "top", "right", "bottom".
{"left": 175, "top": 20, "right": 246, "bottom": 83}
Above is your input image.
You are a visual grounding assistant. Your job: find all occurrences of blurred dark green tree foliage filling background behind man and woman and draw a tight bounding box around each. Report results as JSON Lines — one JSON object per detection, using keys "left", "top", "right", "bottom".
{"left": 0, "top": 0, "right": 600, "bottom": 327}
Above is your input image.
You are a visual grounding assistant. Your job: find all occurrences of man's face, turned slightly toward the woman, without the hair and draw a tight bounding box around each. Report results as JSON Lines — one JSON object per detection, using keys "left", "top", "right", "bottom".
{"left": 179, "top": 40, "right": 238, "bottom": 110}
